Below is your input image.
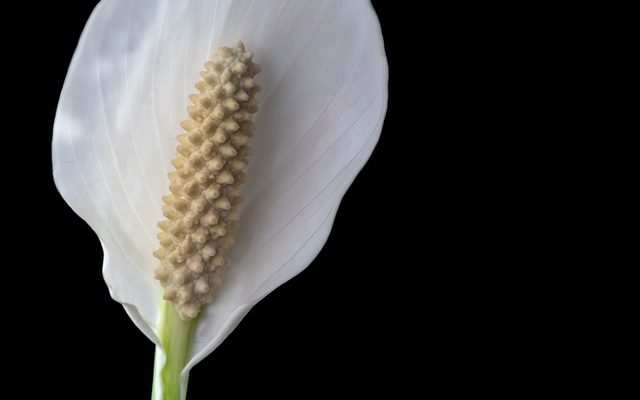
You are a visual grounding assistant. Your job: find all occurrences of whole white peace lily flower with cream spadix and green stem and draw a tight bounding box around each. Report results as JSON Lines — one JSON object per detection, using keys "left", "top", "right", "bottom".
{"left": 53, "top": 0, "right": 387, "bottom": 399}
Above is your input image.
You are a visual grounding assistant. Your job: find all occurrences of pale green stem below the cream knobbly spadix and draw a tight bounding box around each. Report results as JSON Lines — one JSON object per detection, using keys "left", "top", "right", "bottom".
{"left": 151, "top": 300, "right": 197, "bottom": 400}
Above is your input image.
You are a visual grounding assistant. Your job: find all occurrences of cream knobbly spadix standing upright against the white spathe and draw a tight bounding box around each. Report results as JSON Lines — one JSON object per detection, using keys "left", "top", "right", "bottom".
{"left": 154, "top": 42, "right": 260, "bottom": 319}
